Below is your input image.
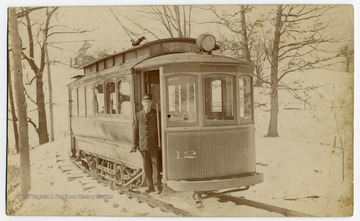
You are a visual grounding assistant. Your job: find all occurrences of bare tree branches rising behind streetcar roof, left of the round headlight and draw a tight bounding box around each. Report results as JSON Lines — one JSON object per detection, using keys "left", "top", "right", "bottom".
{"left": 110, "top": 5, "right": 192, "bottom": 39}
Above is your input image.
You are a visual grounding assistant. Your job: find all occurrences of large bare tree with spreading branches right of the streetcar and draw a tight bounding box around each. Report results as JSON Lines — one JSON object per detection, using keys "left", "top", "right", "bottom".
{"left": 263, "top": 5, "right": 339, "bottom": 137}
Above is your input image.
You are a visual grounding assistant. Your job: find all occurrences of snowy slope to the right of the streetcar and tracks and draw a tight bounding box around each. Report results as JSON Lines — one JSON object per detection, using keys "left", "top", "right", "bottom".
{"left": 247, "top": 70, "right": 353, "bottom": 216}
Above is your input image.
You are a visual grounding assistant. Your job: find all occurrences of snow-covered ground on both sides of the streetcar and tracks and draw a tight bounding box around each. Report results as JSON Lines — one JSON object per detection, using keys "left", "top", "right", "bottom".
{"left": 7, "top": 70, "right": 353, "bottom": 216}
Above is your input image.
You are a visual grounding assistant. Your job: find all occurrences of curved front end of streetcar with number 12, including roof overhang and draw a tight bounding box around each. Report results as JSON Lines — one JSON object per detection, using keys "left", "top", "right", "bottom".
{"left": 135, "top": 53, "right": 263, "bottom": 192}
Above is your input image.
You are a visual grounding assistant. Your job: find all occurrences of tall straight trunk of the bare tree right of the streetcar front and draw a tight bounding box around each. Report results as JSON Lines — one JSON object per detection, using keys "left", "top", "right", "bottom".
{"left": 267, "top": 5, "right": 282, "bottom": 137}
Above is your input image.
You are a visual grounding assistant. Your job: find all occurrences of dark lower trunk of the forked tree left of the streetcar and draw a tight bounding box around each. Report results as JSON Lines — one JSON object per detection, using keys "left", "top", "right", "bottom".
{"left": 36, "top": 73, "right": 49, "bottom": 145}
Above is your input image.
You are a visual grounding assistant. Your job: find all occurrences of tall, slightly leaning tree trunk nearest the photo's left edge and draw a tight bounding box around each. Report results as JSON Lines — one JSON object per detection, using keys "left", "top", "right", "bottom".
{"left": 9, "top": 8, "right": 31, "bottom": 194}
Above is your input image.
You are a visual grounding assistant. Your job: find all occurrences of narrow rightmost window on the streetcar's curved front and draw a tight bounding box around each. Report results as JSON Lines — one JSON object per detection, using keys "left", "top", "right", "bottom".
{"left": 239, "top": 75, "right": 253, "bottom": 123}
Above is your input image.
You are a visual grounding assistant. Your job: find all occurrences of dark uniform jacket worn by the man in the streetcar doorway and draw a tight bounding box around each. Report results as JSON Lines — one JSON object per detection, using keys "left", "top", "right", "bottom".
{"left": 133, "top": 109, "right": 161, "bottom": 151}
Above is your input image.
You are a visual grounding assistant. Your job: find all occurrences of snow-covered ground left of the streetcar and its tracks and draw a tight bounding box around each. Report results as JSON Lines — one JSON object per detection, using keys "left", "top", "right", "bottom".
{"left": 8, "top": 138, "right": 174, "bottom": 216}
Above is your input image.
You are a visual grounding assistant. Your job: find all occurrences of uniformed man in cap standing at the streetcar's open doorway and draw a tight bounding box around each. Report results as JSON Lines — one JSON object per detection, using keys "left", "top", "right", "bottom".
{"left": 130, "top": 94, "right": 161, "bottom": 194}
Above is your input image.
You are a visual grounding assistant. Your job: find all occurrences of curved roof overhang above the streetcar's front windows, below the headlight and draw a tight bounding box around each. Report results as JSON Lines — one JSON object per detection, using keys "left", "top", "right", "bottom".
{"left": 134, "top": 52, "right": 252, "bottom": 69}
